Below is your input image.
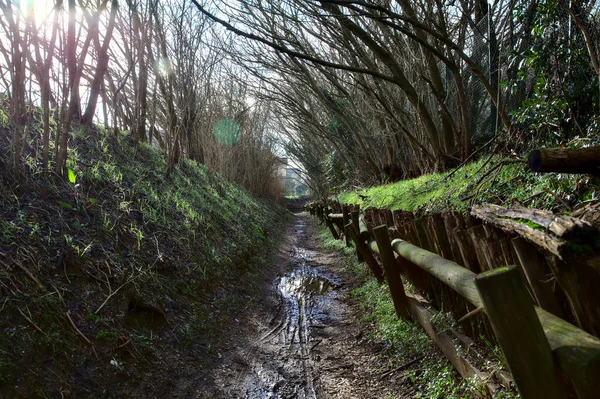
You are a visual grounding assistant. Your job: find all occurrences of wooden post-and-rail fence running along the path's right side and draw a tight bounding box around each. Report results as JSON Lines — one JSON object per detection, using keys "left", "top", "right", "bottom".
{"left": 308, "top": 204, "right": 600, "bottom": 399}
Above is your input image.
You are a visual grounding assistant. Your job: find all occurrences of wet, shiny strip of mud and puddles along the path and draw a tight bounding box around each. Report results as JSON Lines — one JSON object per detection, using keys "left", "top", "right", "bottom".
{"left": 244, "top": 218, "right": 339, "bottom": 399}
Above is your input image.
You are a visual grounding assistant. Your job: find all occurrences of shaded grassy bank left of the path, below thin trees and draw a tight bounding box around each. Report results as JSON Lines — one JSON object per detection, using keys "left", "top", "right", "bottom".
{"left": 0, "top": 130, "right": 285, "bottom": 397}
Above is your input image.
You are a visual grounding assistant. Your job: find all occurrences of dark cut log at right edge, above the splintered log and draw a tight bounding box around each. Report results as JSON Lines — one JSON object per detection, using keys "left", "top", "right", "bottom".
{"left": 527, "top": 146, "right": 600, "bottom": 175}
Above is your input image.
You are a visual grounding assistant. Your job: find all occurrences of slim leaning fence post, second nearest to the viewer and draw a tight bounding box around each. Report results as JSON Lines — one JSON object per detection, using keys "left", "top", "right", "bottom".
{"left": 373, "top": 224, "right": 410, "bottom": 320}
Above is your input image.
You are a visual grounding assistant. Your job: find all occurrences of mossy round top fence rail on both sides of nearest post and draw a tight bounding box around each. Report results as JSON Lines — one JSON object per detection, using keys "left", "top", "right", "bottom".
{"left": 392, "top": 239, "right": 600, "bottom": 398}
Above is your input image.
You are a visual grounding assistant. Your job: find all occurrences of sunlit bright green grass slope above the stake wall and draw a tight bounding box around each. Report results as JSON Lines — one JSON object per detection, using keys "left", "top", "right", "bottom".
{"left": 338, "top": 157, "right": 600, "bottom": 212}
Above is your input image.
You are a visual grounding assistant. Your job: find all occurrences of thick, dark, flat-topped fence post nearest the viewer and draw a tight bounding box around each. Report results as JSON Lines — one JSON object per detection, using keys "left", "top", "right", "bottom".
{"left": 475, "top": 266, "right": 565, "bottom": 399}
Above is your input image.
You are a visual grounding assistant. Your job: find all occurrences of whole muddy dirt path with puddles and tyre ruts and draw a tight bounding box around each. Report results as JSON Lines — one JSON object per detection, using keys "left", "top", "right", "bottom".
{"left": 196, "top": 215, "right": 402, "bottom": 399}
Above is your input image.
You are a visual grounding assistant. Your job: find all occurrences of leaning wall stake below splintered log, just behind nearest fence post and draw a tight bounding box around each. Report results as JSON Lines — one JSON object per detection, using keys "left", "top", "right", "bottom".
{"left": 511, "top": 237, "right": 563, "bottom": 318}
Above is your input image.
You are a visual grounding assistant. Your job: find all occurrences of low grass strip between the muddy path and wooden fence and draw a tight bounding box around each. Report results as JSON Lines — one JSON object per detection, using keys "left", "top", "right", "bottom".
{"left": 319, "top": 227, "right": 519, "bottom": 399}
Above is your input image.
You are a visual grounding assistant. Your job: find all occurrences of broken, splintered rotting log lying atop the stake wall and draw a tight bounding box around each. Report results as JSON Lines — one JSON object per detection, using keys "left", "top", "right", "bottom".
{"left": 471, "top": 204, "right": 600, "bottom": 259}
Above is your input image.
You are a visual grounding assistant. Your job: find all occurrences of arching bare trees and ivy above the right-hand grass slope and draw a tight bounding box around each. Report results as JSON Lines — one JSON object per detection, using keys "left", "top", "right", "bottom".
{"left": 194, "top": 0, "right": 600, "bottom": 194}
